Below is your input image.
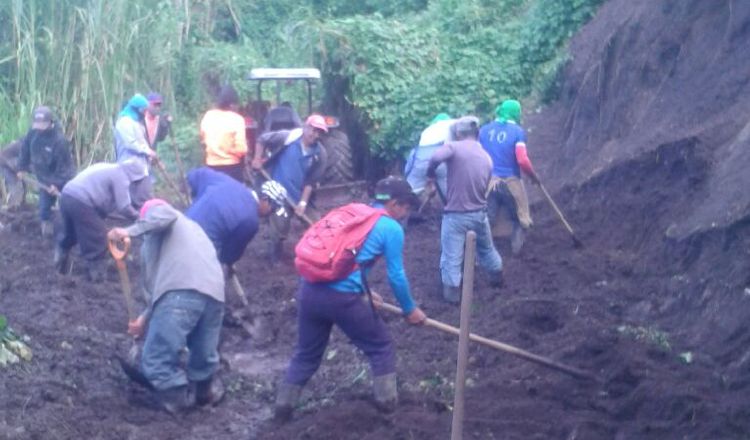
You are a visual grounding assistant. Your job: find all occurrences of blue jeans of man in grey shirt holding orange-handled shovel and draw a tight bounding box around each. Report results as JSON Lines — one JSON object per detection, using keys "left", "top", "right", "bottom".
{"left": 141, "top": 290, "right": 224, "bottom": 390}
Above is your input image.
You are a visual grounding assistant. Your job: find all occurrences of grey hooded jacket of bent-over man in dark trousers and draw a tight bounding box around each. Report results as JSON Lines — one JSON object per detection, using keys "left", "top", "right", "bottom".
{"left": 62, "top": 160, "right": 146, "bottom": 219}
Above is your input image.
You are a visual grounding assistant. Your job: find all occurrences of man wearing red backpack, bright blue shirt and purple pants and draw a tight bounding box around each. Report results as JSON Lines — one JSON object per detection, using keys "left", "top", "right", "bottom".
{"left": 276, "top": 177, "right": 427, "bottom": 420}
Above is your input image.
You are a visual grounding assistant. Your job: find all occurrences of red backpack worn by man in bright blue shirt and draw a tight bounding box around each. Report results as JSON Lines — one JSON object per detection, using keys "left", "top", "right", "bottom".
{"left": 294, "top": 203, "right": 387, "bottom": 283}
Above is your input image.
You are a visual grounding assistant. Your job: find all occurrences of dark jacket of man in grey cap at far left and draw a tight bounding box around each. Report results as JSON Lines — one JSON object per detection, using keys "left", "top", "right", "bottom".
{"left": 18, "top": 123, "right": 75, "bottom": 188}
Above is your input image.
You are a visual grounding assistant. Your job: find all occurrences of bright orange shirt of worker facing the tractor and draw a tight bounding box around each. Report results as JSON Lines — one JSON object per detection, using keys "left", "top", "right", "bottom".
{"left": 200, "top": 109, "right": 247, "bottom": 165}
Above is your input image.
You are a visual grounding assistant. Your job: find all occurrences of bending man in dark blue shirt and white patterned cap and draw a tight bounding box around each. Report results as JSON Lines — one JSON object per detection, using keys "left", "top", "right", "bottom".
{"left": 185, "top": 167, "right": 286, "bottom": 270}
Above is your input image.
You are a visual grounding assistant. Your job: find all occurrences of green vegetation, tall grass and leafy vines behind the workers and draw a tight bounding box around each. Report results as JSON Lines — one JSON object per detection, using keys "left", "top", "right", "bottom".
{"left": 0, "top": 0, "right": 603, "bottom": 165}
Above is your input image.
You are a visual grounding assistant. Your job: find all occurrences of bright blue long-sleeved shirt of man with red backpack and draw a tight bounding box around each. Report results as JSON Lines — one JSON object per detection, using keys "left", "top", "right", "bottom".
{"left": 326, "top": 204, "right": 417, "bottom": 314}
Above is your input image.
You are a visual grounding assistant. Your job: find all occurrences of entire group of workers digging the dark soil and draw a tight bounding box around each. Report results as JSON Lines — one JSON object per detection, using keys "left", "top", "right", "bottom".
{"left": 0, "top": 86, "right": 538, "bottom": 420}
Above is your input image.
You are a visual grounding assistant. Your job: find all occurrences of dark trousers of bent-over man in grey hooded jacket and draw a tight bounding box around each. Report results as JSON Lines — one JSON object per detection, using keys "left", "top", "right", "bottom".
{"left": 58, "top": 194, "right": 107, "bottom": 261}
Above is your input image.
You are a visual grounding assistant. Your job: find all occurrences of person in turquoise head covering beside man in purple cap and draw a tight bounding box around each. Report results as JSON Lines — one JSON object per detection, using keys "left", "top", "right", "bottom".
{"left": 115, "top": 93, "right": 158, "bottom": 207}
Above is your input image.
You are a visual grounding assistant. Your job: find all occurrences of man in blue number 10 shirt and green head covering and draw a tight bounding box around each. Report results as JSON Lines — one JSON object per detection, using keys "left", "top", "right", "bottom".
{"left": 479, "top": 99, "right": 539, "bottom": 254}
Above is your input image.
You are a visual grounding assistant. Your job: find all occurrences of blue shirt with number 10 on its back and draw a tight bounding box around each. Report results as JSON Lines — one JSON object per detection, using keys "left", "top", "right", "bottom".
{"left": 479, "top": 121, "right": 526, "bottom": 177}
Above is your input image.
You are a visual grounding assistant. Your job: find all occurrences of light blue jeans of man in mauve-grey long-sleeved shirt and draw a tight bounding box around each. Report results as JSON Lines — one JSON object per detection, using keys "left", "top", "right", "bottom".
{"left": 440, "top": 211, "right": 503, "bottom": 287}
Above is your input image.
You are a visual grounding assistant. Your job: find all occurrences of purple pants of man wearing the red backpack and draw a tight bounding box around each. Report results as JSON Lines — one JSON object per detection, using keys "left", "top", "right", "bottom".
{"left": 284, "top": 281, "right": 396, "bottom": 385}
